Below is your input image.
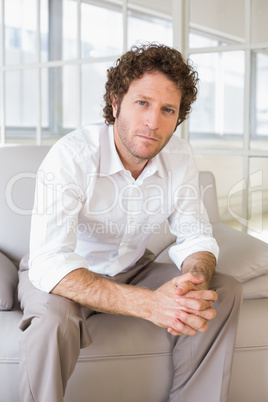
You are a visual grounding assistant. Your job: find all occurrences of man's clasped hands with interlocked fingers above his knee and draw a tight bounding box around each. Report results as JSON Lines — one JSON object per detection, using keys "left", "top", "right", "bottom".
{"left": 155, "top": 273, "right": 218, "bottom": 336}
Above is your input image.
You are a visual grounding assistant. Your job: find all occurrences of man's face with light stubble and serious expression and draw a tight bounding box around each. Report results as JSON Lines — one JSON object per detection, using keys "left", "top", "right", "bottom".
{"left": 113, "top": 72, "right": 181, "bottom": 167}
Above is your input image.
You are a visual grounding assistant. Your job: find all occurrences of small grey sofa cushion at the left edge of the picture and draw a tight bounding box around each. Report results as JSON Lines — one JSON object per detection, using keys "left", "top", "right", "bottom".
{"left": 0, "top": 252, "right": 18, "bottom": 310}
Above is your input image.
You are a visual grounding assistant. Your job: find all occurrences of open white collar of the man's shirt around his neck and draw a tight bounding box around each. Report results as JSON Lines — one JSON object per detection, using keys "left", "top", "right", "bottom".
{"left": 100, "top": 124, "right": 165, "bottom": 178}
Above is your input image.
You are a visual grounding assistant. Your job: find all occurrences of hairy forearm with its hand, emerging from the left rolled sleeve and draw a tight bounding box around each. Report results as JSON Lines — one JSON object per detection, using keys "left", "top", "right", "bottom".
{"left": 51, "top": 268, "right": 209, "bottom": 335}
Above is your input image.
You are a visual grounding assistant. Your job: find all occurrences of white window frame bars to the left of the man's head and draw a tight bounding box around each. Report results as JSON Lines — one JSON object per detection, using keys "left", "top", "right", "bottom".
{"left": 0, "top": 0, "right": 171, "bottom": 145}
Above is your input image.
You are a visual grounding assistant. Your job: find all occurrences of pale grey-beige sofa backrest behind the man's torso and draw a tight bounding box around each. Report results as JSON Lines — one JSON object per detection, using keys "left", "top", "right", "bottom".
{"left": 0, "top": 145, "right": 218, "bottom": 263}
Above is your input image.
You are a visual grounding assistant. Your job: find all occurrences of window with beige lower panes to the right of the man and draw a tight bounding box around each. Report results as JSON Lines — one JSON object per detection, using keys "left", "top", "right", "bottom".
{"left": 186, "top": 0, "right": 268, "bottom": 242}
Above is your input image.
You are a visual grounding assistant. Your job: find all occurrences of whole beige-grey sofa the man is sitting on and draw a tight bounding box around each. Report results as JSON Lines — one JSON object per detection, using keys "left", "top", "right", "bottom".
{"left": 0, "top": 146, "right": 268, "bottom": 402}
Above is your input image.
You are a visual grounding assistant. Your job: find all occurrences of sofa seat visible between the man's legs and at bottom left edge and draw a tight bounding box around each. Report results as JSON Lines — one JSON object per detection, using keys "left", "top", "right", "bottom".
{"left": 0, "top": 307, "right": 172, "bottom": 402}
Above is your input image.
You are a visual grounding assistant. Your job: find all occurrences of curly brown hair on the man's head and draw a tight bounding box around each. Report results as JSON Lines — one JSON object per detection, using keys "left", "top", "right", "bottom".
{"left": 103, "top": 43, "right": 198, "bottom": 127}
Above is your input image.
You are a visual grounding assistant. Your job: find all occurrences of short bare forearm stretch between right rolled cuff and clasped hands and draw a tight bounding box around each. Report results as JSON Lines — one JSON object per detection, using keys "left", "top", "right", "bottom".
{"left": 181, "top": 251, "right": 216, "bottom": 289}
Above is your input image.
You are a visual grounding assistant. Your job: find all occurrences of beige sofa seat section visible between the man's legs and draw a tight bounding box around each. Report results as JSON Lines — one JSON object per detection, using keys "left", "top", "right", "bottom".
{"left": 65, "top": 314, "right": 172, "bottom": 402}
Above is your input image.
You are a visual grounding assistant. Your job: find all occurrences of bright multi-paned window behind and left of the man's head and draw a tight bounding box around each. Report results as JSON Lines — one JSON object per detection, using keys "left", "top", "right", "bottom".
{"left": 0, "top": 0, "right": 172, "bottom": 144}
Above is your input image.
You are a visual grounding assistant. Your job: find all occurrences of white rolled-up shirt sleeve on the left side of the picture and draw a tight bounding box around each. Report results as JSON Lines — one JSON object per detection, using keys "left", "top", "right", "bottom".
{"left": 29, "top": 140, "right": 87, "bottom": 293}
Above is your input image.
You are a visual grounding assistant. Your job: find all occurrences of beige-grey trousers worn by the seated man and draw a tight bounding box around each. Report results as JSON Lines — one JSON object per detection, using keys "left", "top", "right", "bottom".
{"left": 19, "top": 254, "right": 242, "bottom": 402}
